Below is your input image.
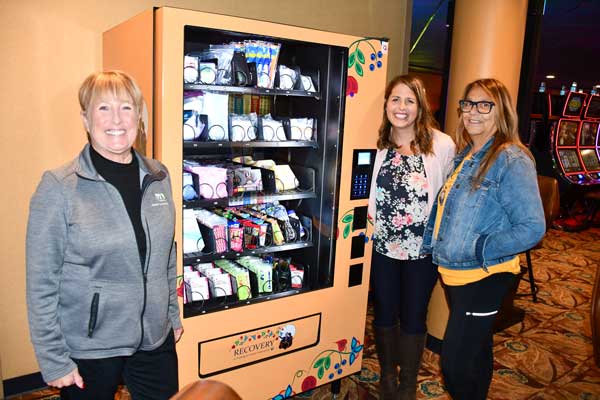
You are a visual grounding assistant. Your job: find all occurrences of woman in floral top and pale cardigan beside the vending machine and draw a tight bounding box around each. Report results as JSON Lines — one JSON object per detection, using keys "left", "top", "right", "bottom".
{"left": 369, "top": 75, "right": 455, "bottom": 399}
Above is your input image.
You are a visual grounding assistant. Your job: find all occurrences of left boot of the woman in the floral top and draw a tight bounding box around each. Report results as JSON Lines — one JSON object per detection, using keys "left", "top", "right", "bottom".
{"left": 374, "top": 327, "right": 398, "bottom": 400}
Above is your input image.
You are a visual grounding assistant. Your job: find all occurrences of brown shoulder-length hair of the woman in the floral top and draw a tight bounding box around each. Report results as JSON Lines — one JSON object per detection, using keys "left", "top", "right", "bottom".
{"left": 377, "top": 75, "right": 438, "bottom": 154}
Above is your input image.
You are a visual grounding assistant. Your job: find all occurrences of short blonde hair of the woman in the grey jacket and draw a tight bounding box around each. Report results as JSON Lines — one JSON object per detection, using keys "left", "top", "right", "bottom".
{"left": 79, "top": 70, "right": 145, "bottom": 141}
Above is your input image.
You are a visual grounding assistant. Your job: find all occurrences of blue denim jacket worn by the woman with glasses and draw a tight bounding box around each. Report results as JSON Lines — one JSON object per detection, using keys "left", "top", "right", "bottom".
{"left": 421, "top": 138, "right": 546, "bottom": 271}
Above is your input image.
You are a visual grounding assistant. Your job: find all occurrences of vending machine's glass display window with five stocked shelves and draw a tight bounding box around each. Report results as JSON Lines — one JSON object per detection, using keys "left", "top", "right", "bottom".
{"left": 183, "top": 26, "right": 347, "bottom": 317}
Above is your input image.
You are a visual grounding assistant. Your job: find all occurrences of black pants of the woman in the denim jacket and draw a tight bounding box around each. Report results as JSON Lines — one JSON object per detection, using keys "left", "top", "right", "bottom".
{"left": 441, "top": 272, "right": 515, "bottom": 400}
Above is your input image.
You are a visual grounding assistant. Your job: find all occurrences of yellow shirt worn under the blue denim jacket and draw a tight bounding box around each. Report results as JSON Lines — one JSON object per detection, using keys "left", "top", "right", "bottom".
{"left": 433, "top": 153, "right": 521, "bottom": 286}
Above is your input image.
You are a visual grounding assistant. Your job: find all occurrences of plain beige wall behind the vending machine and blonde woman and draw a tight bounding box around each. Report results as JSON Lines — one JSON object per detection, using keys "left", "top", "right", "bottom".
{"left": 0, "top": 0, "right": 412, "bottom": 379}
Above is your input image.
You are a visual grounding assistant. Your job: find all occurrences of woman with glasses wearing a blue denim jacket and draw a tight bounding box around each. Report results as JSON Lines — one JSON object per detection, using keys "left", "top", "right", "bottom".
{"left": 421, "top": 79, "right": 545, "bottom": 400}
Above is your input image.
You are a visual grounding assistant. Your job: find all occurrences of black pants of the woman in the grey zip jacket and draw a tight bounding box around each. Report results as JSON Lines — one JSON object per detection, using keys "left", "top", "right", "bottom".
{"left": 60, "top": 331, "right": 179, "bottom": 400}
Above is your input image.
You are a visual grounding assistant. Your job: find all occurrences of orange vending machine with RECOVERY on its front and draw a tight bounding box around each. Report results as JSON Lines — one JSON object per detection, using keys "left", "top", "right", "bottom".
{"left": 103, "top": 7, "right": 388, "bottom": 399}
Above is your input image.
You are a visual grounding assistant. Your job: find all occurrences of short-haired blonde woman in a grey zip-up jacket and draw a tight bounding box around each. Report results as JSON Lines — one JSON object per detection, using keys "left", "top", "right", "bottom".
{"left": 27, "top": 71, "right": 183, "bottom": 400}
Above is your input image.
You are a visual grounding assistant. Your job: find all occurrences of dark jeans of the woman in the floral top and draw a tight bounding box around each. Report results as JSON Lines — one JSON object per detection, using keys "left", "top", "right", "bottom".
{"left": 371, "top": 251, "right": 438, "bottom": 335}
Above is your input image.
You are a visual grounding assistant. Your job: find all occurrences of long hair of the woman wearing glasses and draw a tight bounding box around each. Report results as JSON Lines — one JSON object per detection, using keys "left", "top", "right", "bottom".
{"left": 456, "top": 78, "right": 533, "bottom": 188}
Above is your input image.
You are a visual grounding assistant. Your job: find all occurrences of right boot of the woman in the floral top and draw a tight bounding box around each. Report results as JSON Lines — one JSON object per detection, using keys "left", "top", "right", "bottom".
{"left": 397, "top": 333, "right": 425, "bottom": 400}
